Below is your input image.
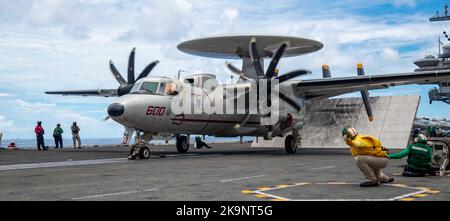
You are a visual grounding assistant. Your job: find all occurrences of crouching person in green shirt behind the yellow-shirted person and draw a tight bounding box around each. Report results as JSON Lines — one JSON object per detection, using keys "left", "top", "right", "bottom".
{"left": 389, "top": 134, "right": 436, "bottom": 176}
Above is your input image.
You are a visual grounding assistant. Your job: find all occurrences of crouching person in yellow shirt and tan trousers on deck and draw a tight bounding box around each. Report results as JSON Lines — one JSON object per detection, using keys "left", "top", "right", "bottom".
{"left": 342, "top": 127, "right": 394, "bottom": 187}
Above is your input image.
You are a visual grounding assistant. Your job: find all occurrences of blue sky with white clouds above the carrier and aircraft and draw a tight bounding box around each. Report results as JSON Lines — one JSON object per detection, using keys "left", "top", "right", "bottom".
{"left": 0, "top": 0, "right": 450, "bottom": 139}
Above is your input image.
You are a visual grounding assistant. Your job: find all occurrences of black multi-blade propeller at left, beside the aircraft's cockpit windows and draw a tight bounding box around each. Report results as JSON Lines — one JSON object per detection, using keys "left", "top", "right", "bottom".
{"left": 109, "top": 48, "right": 159, "bottom": 96}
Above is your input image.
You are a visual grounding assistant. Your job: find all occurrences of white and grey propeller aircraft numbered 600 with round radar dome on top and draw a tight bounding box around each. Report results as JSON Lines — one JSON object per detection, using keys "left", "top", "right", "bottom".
{"left": 46, "top": 35, "right": 450, "bottom": 159}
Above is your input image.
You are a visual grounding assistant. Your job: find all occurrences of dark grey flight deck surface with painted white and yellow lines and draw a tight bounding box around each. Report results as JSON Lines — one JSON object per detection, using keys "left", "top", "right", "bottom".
{"left": 0, "top": 144, "right": 450, "bottom": 201}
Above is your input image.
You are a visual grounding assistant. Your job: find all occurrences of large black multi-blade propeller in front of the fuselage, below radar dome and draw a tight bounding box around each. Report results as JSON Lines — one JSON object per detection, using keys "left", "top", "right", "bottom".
{"left": 226, "top": 38, "right": 311, "bottom": 137}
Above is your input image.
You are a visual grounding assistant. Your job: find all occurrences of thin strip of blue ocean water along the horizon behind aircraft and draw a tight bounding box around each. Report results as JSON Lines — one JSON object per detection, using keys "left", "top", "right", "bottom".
{"left": 0, "top": 136, "right": 252, "bottom": 149}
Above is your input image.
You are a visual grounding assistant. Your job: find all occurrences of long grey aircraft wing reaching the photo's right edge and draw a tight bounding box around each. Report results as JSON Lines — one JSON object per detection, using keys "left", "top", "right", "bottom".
{"left": 292, "top": 70, "right": 450, "bottom": 99}
